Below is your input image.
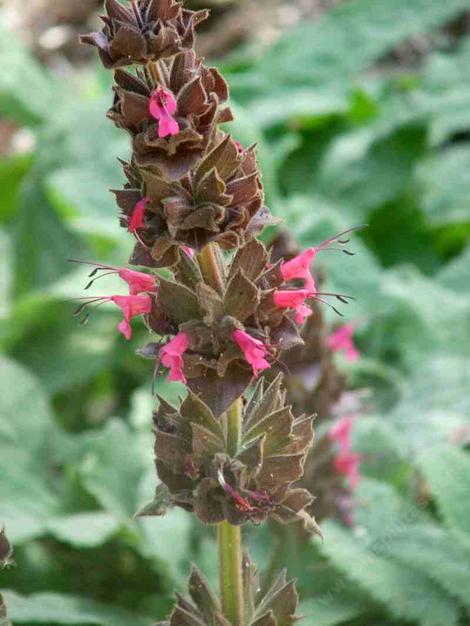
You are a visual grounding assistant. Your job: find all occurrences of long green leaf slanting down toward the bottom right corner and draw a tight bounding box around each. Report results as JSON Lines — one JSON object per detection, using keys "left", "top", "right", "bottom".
{"left": 321, "top": 522, "right": 458, "bottom": 626}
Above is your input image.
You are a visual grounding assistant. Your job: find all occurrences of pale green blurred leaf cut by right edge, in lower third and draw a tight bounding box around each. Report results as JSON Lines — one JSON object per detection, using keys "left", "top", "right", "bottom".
{"left": 417, "top": 444, "right": 470, "bottom": 535}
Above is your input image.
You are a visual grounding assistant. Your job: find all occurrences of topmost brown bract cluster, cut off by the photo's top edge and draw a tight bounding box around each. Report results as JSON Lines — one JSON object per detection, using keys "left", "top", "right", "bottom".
{"left": 81, "top": 0, "right": 209, "bottom": 68}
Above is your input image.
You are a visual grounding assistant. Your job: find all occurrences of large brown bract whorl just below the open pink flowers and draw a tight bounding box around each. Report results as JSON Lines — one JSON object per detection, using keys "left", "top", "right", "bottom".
{"left": 154, "top": 376, "right": 317, "bottom": 531}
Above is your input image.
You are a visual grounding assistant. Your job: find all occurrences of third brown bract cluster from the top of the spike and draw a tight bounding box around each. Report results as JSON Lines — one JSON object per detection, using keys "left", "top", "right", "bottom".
{"left": 116, "top": 131, "right": 275, "bottom": 258}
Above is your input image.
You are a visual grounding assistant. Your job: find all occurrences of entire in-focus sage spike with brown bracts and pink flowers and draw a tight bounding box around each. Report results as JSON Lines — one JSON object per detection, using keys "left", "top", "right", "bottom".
{"left": 80, "top": 0, "right": 356, "bottom": 626}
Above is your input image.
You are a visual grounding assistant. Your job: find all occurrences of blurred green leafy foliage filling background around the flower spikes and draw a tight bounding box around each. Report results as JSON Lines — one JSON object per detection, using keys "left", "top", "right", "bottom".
{"left": 0, "top": 0, "right": 470, "bottom": 626}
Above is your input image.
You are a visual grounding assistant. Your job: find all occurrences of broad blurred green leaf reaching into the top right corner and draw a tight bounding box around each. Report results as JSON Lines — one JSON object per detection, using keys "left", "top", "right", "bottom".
{"left": 246, "top": 0, "right": 468, "bottom": 90}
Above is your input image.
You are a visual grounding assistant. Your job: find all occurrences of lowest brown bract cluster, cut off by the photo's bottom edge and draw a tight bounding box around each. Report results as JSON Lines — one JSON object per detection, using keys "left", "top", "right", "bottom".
{"left": 156, "top": 556, "right": 299, "bottom": 626}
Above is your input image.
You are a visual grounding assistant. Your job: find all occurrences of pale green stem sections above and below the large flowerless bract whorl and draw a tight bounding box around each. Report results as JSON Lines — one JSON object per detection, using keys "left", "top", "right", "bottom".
{"left": 217, "top": 398, "right": 244, "bottom": 626}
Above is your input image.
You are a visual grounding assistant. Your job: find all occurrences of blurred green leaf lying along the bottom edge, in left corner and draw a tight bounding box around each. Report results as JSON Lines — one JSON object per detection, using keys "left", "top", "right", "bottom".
{"left": 3, "top": 591, "right": 152, "bottom": 626}
